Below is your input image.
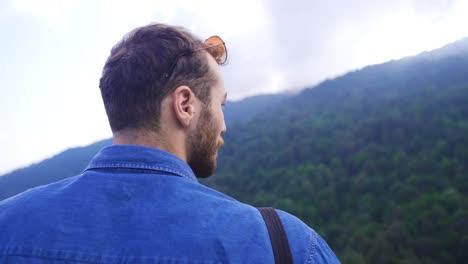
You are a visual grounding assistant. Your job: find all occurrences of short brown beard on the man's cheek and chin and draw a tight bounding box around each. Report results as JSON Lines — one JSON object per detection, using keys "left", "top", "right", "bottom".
{"left": 187, "top": 106, "right": 224, "bottom": 178}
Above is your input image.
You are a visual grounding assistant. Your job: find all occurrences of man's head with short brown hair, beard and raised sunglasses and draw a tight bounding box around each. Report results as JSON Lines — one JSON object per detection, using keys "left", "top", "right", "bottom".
{"left": 99, "top": 24, "right": 226, "bottom": 177}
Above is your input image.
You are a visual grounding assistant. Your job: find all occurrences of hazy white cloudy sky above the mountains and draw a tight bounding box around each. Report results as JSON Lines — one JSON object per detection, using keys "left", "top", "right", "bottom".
{"left": 0, "top": 0, "right": 468, "bottom": 174}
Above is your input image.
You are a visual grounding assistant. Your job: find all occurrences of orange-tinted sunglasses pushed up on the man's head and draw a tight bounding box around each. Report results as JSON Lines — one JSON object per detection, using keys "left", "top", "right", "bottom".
{"left": 164, "top": 36, "right": 227, "bottom": 78}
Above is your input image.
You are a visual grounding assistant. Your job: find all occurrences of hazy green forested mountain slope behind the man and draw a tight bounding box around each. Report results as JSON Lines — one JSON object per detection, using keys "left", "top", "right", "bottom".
{"left": 0, "top": 36, "right": 468, "bottom": 263}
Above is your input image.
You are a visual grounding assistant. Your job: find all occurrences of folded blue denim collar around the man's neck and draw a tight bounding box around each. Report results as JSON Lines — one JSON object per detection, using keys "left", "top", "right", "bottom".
{"left": 85, "top": 145, "right": 197, "bottom": 181}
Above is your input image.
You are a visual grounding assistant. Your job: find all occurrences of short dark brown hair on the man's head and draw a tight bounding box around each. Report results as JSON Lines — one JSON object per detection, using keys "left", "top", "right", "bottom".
{"left": 99, "top": 24, "right": 215, "bottom": 132}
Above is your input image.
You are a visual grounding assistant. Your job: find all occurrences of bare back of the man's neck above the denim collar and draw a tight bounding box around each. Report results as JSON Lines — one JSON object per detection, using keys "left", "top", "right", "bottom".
{"left": 112, "top": 129, "right": 187, "bottom": 161}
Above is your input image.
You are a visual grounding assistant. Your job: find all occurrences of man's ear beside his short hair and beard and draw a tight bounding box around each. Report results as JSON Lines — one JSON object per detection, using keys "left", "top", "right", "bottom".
{"left": 172, "top": 86, "right": 196, "bottom": 127}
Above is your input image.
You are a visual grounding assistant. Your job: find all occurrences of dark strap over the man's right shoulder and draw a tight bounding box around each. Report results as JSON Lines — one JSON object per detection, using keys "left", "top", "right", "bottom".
{"left": 257, "top": 207, "right": 293, "bottom": 264}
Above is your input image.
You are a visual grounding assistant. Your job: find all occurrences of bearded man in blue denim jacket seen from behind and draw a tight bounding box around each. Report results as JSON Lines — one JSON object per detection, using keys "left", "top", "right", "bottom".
{"left": 0, "top": 24, "right": 338, "bottom": 264}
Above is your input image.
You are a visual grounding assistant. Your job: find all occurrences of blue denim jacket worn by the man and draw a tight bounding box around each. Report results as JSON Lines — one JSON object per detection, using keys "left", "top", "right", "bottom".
{"left": 0, "top": 145, "right": 339, "bottom": 264}
